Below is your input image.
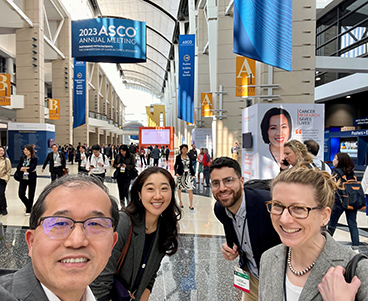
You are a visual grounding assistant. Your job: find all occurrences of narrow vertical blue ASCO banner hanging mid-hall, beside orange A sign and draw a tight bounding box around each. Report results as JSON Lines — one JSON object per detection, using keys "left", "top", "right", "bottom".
{"left": 178, "top": 34, "right": 195, "bottom": 123}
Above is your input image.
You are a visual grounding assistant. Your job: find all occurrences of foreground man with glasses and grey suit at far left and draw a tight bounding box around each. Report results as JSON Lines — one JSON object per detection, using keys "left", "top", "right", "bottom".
{"left": 0, "top": 175, "right": 119, "bottom": 301}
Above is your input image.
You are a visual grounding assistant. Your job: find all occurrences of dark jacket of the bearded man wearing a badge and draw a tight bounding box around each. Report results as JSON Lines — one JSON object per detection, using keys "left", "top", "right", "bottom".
{"left": 215, "top": 188, "right": 280, "bottom": 270}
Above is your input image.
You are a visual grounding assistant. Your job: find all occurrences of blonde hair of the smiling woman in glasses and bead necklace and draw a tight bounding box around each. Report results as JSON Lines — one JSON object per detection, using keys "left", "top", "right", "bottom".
{"left": 271, "top": 165, "right": 338, "bottom": 209}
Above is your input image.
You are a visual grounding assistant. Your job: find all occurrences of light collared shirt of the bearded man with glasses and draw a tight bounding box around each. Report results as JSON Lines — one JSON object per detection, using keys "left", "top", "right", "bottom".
{"left": 225, "top": 194, "right": 259, "bottom": 279}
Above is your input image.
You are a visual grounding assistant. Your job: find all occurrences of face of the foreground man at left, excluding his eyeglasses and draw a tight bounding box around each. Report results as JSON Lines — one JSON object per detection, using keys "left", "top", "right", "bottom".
{"left": 26, "top": 185, "right": 117, "bottom": 296}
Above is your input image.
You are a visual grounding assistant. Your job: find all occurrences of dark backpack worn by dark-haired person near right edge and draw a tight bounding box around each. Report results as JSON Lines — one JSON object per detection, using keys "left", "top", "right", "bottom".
{"left": 336, "top": 169, "right": 365, "bottom": 210}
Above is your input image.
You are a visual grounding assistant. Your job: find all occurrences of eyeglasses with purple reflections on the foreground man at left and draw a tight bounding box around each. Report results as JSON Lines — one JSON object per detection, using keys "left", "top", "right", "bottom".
{"left": 36, "top": 216, "right": 114, "bottom": 239}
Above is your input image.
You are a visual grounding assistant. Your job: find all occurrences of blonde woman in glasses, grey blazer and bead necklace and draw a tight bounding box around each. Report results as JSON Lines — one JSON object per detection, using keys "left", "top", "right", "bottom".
{"left": 259, "top": 166, "right": 368, "bottom": 301}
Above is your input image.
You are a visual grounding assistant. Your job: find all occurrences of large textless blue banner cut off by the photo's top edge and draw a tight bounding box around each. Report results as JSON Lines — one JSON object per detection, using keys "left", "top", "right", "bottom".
{"left": 233, "top": 0, "right": 293, "bottom": 71}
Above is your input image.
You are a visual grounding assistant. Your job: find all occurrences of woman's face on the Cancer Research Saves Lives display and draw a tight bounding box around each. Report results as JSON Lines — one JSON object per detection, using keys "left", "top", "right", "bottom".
{"left": 267, "top": 115, "right": 290, "bottom": 148}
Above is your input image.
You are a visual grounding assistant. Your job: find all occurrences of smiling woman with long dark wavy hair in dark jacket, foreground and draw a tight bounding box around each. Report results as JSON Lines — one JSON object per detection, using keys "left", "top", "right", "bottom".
{"left": 91, "top": 167, "right": 181, "bottom": 301}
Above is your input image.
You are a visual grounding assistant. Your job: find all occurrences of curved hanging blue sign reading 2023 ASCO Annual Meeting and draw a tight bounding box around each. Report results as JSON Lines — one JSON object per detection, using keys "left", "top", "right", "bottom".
{"left": 72, "top": 18, "right": 147, "bottom": 63}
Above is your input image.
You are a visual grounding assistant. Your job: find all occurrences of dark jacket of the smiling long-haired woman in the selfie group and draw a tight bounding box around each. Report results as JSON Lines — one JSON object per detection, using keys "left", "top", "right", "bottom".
{"left": 90, "top": 212, "right": 165, "bottom": 300}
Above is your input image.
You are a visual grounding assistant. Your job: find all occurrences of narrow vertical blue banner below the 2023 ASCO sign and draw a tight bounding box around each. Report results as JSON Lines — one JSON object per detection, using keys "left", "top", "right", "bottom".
{"left": 73, "top": 60, "right": 86, "bottom": 128}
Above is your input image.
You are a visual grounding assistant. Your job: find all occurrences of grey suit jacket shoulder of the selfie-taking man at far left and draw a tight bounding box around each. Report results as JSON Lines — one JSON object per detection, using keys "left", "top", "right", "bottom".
{"left": 0, "top": 263, "right": 48, "bottom": 301}
